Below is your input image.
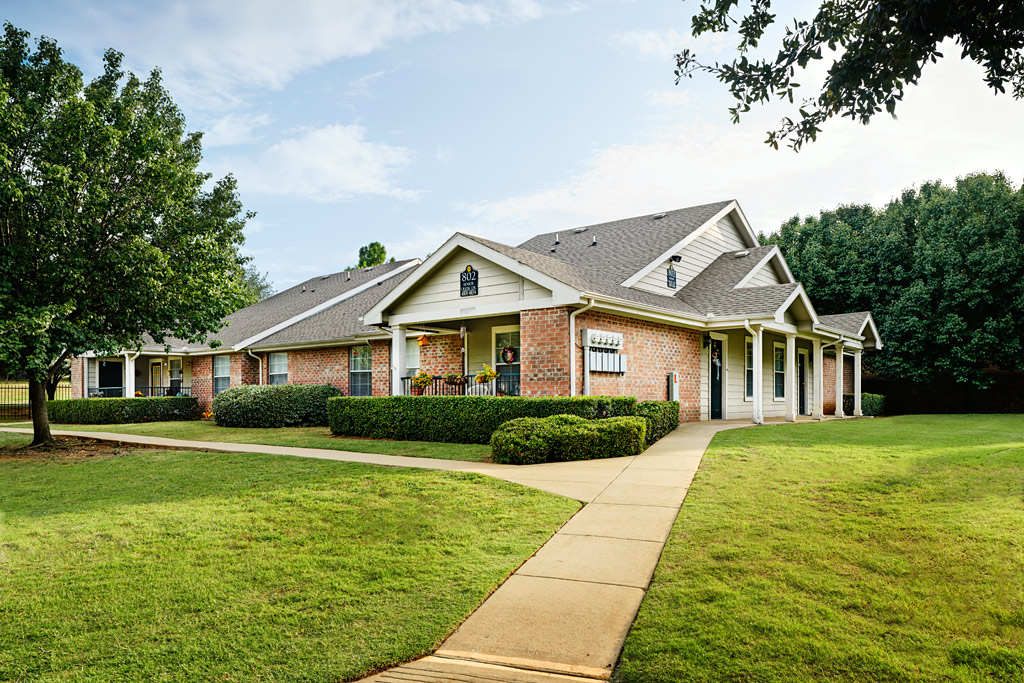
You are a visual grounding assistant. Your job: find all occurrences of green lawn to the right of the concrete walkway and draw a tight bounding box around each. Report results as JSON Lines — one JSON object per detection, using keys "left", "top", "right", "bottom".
{"left": 615, "top": 415, "right": 1024, "bottom": 683}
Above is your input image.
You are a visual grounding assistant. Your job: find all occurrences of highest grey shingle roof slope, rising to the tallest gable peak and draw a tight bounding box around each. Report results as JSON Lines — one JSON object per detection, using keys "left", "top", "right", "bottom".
{"left": 519, "top": 200, "right": 732, "bottom": 285}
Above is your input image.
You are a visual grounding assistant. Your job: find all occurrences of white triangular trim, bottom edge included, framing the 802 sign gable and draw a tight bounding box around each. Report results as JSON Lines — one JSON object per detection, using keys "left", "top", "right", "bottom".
{"left": 362, "top": 232, "right": 581, "bottom": 325}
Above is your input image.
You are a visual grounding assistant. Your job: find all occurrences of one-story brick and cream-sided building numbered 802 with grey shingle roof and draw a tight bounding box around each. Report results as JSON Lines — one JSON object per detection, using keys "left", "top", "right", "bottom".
{"left": 72, "top": 201, "right": 882, "bottom": 422}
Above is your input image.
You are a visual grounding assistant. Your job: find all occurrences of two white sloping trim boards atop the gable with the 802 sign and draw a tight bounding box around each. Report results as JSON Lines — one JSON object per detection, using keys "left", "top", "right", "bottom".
{"left": 362, "top": 232, "right": 582, "bottom": 325}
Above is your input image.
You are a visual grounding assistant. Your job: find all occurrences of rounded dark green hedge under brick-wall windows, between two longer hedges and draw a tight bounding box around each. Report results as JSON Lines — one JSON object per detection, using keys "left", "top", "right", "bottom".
{"left": 213, "top": 384, "right": 341, "bottom": 427}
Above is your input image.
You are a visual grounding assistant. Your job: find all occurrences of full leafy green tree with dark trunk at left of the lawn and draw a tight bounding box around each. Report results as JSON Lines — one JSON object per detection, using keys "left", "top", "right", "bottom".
{"left": 0, "top": 24, "right": 251, "bottom": 445}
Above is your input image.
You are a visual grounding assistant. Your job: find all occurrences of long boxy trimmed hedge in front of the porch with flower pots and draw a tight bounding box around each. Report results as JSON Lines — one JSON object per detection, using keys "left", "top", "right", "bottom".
{"left": 325, "top": 392, "right": 637, "bottom": 443}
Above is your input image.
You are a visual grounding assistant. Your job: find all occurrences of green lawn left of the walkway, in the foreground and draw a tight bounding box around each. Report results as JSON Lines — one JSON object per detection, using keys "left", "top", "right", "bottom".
{"left": 0, "top": 434, "right": 578, "bottom": 682}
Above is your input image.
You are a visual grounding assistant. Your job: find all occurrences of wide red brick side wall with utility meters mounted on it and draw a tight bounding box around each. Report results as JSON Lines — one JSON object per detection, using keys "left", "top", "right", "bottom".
{"left": 575, "top": 311, "right": 700, "bottom": 422}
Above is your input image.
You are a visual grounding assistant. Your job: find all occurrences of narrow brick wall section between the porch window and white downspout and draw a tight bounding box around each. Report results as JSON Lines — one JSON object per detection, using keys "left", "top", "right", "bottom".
{"left": 519, "top": 306, "right": 570, "bottom": 396}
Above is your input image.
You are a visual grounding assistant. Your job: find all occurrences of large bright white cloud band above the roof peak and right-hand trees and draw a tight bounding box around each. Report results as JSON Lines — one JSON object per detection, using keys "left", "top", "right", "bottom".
{"left": 438, "top": 50, "right": 1024, "bottom": 249}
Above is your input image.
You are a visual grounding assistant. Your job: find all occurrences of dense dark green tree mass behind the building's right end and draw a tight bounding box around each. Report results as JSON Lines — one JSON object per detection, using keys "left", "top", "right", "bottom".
{"left": 762, "top": 173, "right": 1024, "bottom": 387}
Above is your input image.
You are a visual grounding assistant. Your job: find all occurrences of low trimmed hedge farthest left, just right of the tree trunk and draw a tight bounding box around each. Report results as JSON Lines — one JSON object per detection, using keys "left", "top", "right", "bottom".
{"left": 47, "top": 396, "right": 199, "bottom": 425}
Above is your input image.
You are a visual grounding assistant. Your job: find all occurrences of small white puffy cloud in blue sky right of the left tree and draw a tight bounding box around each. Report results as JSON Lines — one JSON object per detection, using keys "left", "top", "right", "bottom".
{"left": 230, "top": 124, "right": 419, "bottom": 202}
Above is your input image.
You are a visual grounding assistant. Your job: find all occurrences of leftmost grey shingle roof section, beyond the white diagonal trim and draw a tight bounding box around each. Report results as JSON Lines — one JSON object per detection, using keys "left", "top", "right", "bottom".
{"left": 143, "top": 259, "right": 413, "bottom": 351}
